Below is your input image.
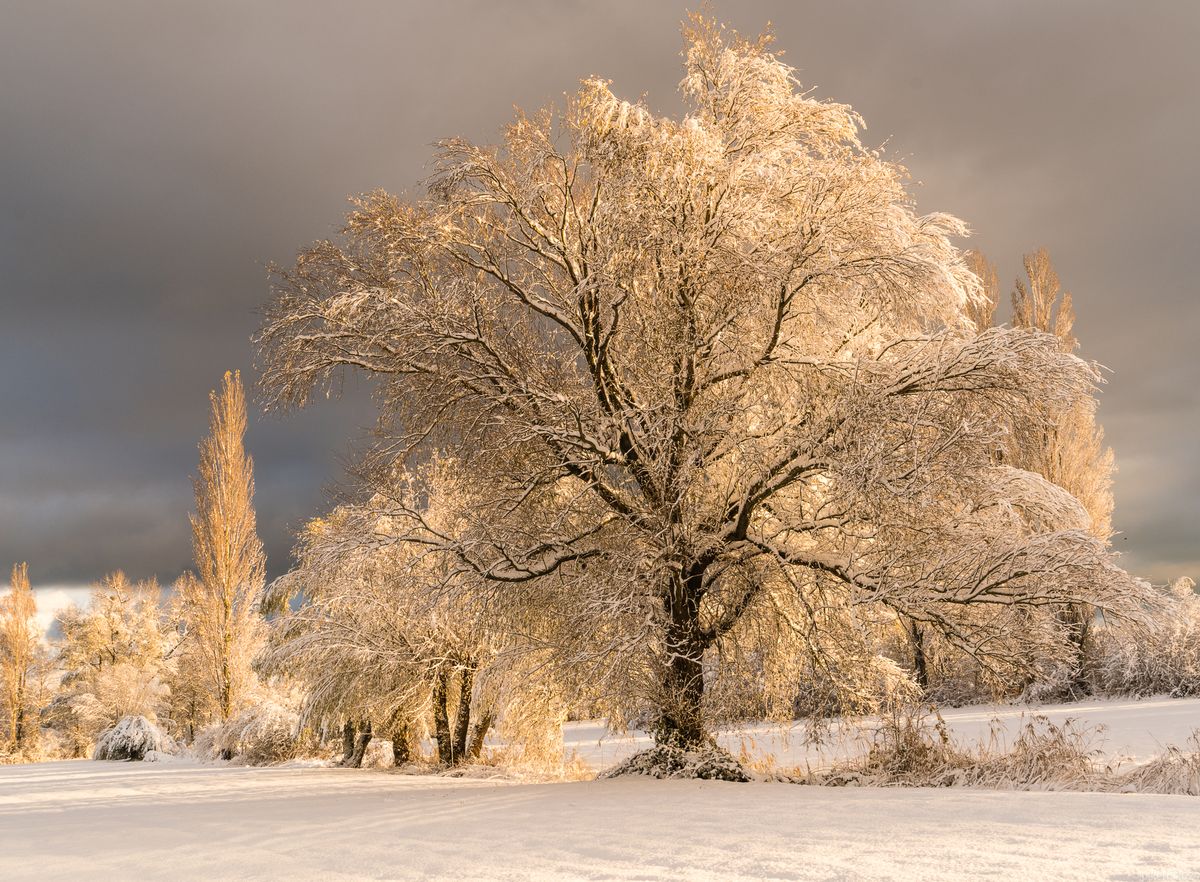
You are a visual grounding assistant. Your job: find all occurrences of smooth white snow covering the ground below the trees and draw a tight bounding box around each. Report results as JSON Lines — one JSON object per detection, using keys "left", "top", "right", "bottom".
{"left": 0, "top": 701, "right": 1200, "bottom": 882}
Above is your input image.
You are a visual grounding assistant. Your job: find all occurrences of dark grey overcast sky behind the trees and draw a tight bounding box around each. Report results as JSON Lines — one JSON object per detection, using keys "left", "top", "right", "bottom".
{"left": 0, "top": 0, "right": 1200, "bottom": 600}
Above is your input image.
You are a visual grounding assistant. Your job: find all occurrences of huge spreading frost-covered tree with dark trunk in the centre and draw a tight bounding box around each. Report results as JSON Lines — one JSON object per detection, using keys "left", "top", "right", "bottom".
{"left": 259, "top": 17, "right": 1138, "bottom": 745}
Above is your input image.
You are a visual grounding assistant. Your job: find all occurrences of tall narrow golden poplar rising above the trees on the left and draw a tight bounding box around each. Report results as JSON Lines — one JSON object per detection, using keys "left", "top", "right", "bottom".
{"left": 178, "top": 372, "right": 266, "bottom": 720}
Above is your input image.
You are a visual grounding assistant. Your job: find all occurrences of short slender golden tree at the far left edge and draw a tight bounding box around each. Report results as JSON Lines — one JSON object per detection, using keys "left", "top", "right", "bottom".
{"left": 0, "top": 564, "right": 43, "bottom": 751}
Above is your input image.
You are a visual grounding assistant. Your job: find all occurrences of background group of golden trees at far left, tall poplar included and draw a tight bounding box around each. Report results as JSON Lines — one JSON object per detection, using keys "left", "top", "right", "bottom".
{"left": 0, "top": 373, "right": 266, "bottom": 756}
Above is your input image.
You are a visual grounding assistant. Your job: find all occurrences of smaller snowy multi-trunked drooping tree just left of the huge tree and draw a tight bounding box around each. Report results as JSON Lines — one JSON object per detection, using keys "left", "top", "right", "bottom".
{"left": 260, "top": 461, "right": 542, "bottom": 766}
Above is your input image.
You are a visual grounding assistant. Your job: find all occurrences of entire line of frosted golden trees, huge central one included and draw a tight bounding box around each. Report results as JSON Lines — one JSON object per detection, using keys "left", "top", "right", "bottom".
{"left": 0, "top": 17, "right": 1200, "bottom": 763}
